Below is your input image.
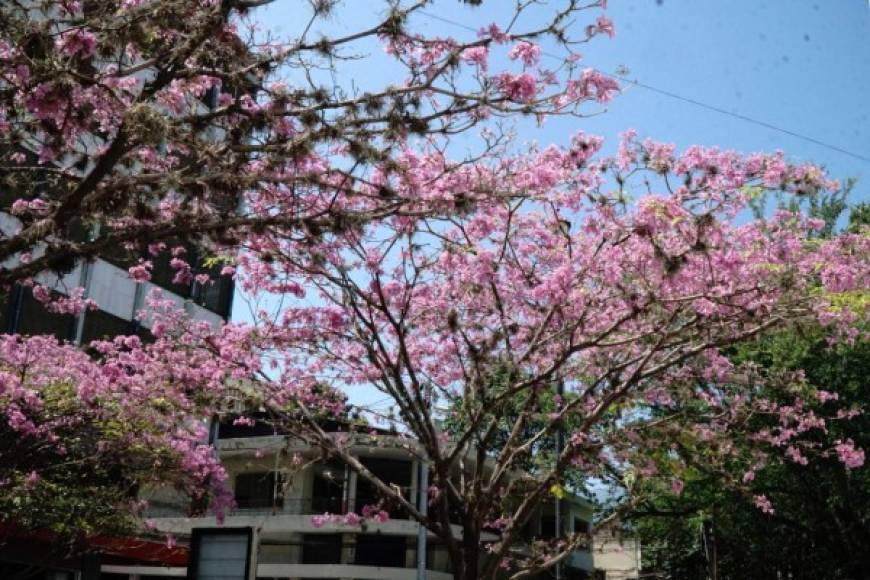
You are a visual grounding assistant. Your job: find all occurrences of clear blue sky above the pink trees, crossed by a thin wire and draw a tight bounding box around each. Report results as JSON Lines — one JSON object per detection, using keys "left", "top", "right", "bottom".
{"left": 256, "top": 0, "right": 870, "bottom": 199}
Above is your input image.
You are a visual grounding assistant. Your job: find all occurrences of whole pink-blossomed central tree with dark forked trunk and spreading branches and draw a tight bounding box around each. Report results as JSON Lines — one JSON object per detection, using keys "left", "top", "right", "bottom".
{"left": 216, "top": 134, "right": 870, "bottom": 578}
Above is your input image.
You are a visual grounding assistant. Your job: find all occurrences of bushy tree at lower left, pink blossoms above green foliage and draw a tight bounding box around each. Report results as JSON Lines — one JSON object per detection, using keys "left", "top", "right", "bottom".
{"left": 0, "top": 335, "right": 230, "bottom": 551}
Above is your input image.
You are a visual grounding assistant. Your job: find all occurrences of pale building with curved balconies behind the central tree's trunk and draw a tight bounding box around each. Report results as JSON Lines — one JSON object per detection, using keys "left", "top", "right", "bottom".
{"left": 102, "top": 416, "right": 593, "bottom": 580}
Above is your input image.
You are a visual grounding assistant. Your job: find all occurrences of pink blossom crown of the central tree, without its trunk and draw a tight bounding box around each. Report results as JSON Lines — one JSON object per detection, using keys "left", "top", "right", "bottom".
{"left": 230, "top": 133, "right": 870, "bottom": 524}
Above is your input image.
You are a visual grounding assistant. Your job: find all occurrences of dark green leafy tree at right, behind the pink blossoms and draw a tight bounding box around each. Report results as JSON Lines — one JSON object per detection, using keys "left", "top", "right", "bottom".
{"left": 631, "top": 204, "right": 870, "bottom": 579}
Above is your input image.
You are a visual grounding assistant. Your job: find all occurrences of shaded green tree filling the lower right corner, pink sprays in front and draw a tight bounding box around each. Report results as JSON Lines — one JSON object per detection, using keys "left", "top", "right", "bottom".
{"left": 628, "top": 203, "right": 870, "bottom": 578}
